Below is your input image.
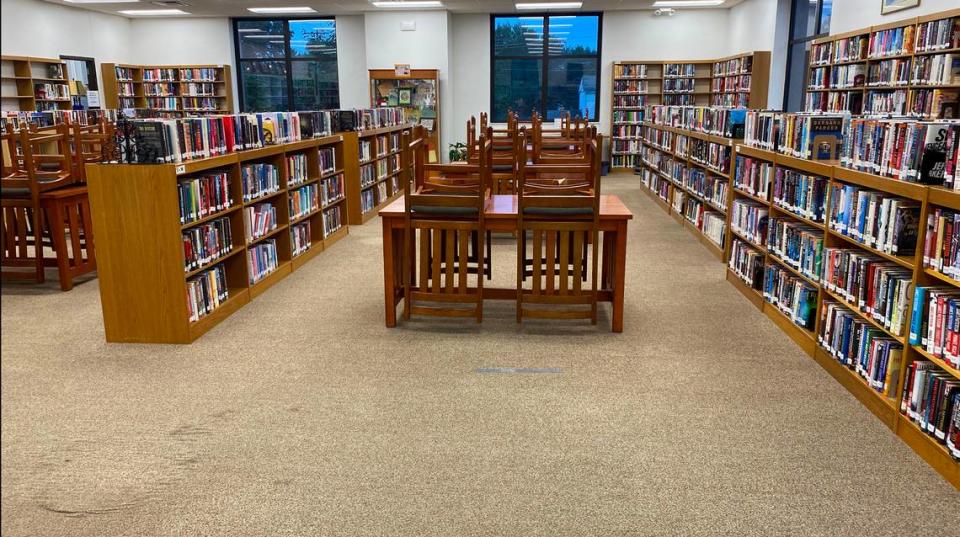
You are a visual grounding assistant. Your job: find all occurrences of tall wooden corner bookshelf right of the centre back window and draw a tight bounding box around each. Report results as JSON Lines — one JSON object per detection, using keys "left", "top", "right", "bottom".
{"left": 610, "top": 51, "right": 770, "bottom": 170}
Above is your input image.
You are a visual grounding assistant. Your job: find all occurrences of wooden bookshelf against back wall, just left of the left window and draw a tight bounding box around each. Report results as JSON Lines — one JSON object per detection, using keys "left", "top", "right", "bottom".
{"left": 100, "top": 63, "right": 233, "bottom": 114}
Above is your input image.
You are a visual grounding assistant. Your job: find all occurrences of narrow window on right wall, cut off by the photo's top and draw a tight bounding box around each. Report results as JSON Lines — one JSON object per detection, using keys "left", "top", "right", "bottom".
{"left": 783, "top": 0, "right": 833, "bottom": 112}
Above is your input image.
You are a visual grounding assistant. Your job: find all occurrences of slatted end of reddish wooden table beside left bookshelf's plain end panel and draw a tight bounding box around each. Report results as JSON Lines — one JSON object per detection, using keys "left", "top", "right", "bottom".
{"left": 40, "top": 185, "right": 97, "bottom": 291}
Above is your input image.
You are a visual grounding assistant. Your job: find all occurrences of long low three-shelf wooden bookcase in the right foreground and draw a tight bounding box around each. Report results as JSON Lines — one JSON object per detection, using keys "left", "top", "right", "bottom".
{"left": 726, "top": 143, "right": 960, "bottom": 488}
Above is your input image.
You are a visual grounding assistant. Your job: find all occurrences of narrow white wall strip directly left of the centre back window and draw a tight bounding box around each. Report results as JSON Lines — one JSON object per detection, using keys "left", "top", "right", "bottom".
{"left": 449, "top": 13, "right": 490, "bottom": 146}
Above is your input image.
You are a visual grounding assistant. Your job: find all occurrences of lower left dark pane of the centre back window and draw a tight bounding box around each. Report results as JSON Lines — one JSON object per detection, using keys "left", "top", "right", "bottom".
{"left": 493, "top": 60, "right": 543, "bottom": 121}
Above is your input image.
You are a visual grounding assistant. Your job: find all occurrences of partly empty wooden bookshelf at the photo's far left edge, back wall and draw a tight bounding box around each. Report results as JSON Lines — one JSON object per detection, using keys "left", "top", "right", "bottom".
{"left": 0, "top": 56, "right": 73, "bottom": 112}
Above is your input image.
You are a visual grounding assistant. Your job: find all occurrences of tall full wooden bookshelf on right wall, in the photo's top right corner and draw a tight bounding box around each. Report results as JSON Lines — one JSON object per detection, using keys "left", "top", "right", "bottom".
{"left": 804, "top": 8, "right": 960, "bottom": 119}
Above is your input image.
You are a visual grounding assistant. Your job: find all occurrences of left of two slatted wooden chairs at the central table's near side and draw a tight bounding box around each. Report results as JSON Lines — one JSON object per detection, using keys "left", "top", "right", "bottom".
{"left": 401, "top": 131, "right": 491, "bottom": 323}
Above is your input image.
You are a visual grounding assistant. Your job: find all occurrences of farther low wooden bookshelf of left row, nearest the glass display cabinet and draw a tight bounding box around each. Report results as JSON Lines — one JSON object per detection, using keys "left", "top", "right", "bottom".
{"left": 343, "top": 124, "right": 412, "bottom": 225}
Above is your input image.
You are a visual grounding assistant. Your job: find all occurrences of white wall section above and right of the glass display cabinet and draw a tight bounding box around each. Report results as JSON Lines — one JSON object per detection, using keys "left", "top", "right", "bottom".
{"left": 364, "top": 11, "right": 454, "bottom": 157}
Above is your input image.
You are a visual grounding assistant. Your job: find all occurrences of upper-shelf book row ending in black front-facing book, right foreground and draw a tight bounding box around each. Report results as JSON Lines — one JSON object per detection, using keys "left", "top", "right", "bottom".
{"left": 829, "top": 183, "right": 920, "bottom": 256}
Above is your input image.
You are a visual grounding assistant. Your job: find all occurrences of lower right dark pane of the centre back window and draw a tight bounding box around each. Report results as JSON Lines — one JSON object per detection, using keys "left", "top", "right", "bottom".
{"left": 547, "top": 58, "right": 597, "bottom": 120}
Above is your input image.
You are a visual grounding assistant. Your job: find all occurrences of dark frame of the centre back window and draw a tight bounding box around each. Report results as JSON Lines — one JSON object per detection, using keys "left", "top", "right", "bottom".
{"left": 490, "top": 11, "right": 603, "bottom": 122}
